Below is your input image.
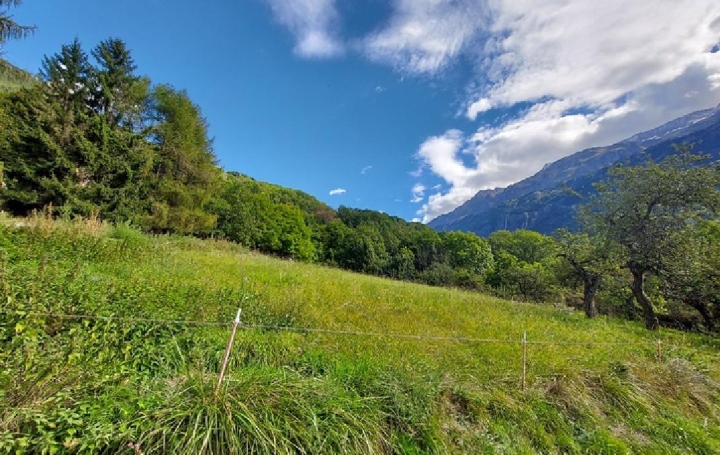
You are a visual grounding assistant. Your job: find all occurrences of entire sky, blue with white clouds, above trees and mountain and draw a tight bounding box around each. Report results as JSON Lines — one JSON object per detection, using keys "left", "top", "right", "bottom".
{"left": 5, "top": 0, "right": 720, "bottom": 221}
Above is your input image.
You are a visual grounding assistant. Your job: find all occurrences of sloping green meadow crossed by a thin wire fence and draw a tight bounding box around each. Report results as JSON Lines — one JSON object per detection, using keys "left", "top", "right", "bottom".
{"left": 0, "top": 216, "right": 720, "bottom": 453}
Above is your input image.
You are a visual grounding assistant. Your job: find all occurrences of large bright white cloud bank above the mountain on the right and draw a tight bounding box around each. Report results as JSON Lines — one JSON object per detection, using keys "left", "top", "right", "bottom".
{"left": 404, "top": 0, "right": 720, "bottom": 222}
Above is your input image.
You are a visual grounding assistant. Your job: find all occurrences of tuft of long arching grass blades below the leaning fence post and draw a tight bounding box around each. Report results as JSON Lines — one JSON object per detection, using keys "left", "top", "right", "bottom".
{"left": 135, "top": 368, "right": 389, "bottom": 454}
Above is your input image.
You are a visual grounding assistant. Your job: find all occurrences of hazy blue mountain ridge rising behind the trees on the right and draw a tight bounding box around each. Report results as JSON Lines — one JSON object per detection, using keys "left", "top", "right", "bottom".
{"left": 429, "top": 106, "right": 720, "bottom": 236}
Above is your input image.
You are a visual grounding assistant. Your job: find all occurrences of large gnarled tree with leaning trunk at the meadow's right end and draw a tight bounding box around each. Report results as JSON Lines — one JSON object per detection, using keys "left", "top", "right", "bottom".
{"left": 584, "top": 150, "right": 720, "bottom": 330}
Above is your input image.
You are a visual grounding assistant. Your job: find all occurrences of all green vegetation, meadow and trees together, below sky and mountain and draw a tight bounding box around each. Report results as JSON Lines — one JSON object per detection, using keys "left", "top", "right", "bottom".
{"left": 0, "top": 0, "right": 720, "bottom": 454}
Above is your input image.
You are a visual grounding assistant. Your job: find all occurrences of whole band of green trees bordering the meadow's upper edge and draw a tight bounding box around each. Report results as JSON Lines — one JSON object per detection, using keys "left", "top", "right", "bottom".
{"left": 0, "top": 32, "right": 720, "bottom": 330}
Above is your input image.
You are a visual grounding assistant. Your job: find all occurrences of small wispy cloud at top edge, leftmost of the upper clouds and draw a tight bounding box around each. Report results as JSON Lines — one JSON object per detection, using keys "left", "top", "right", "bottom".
{"left": 266, "top": 0, "right": 344, "bottom": 58}
